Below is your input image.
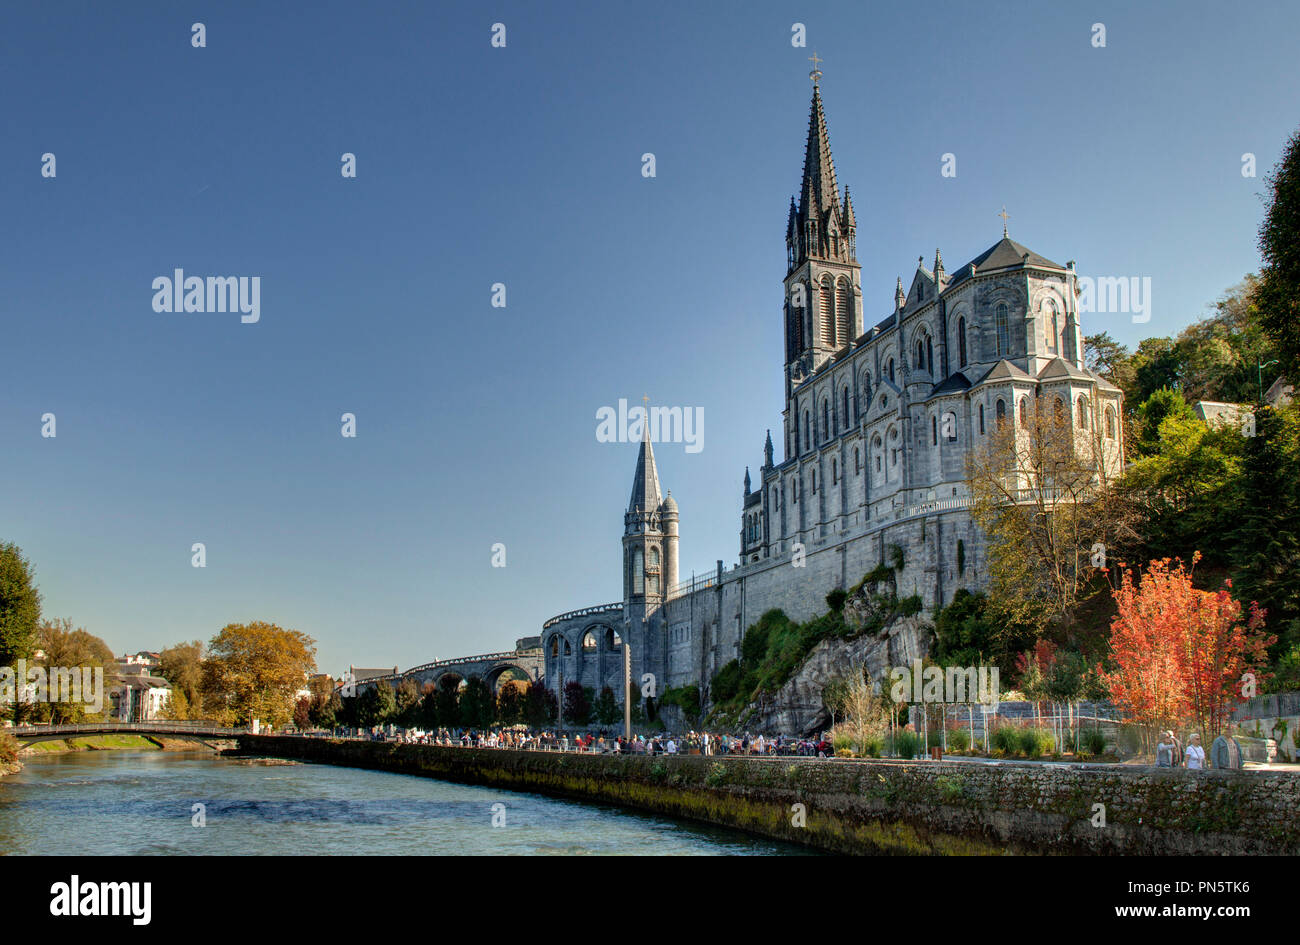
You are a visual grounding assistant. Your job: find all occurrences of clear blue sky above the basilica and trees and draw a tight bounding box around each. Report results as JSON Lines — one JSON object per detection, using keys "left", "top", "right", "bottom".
{"left": 0, "top": 3, "right": 1300, "bottom": 673}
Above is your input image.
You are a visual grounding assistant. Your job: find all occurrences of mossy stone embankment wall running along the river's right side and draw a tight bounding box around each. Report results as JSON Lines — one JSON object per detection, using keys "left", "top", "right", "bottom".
{"left": 239, "top": 736, "right": 1300, "bottom": 855}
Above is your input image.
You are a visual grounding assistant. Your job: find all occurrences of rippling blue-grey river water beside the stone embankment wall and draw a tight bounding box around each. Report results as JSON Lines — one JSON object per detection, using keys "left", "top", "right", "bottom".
{"left": 0, "top": 750, "right": 807, "bottom": 857}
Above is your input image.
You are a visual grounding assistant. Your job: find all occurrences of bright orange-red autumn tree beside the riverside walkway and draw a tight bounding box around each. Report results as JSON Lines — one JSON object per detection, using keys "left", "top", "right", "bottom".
{"left": 1101, "top": 552, "right": 1273, "bottom": 741}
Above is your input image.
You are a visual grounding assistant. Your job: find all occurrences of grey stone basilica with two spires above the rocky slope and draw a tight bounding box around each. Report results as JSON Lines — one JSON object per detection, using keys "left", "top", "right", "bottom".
{"left": 542, "top": 88, "right": 1123, "bottom": 699}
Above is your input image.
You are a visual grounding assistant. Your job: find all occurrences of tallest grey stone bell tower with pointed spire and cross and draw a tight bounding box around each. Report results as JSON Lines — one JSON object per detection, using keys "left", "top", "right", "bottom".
{"left": 785, "top": 83, "right": 862, "bottom": 458}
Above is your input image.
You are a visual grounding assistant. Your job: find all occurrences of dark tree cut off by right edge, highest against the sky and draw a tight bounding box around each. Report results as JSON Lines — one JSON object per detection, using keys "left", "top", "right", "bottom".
{"left": 1256, "top": 131, "right": 1300, "bottom": 378}
